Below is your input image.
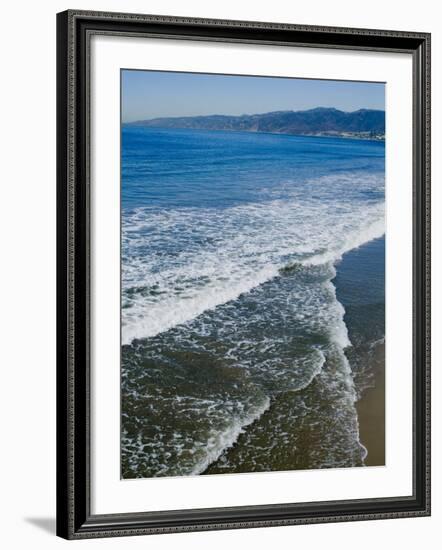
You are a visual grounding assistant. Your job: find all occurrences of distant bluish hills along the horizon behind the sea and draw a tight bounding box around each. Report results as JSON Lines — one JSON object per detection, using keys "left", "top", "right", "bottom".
{"left": 127, "top": 107, "right": 385, "bottom": 139}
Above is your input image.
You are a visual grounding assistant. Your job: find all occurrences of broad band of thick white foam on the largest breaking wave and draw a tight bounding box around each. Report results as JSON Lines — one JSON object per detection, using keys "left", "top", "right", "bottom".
{"left": 122, "top": 174, "right": 385, "bottom": 344}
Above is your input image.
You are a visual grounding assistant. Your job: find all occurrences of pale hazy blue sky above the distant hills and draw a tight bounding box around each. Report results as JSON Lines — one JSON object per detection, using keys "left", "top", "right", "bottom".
{"left": 121, "top": 69, "right": 385, "bottom": 122}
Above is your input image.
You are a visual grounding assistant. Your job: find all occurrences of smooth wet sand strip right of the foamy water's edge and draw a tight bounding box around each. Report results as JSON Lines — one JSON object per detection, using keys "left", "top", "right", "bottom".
{"left": 334, "top": 237, "right": 385, "bottom": 466}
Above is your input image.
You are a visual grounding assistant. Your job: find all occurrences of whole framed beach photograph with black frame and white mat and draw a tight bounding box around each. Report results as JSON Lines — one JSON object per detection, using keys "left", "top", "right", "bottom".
{"left": 57, "top": 10, "right": 430, "bottom": 539}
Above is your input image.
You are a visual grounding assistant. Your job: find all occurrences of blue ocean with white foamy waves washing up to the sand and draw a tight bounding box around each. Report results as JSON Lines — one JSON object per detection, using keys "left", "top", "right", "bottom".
{"left": 121, "top": 126, "right": 385, "bottom": 478}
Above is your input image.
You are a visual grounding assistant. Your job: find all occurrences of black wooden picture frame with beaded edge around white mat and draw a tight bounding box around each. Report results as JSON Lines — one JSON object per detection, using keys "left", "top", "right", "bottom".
{"left": 57, "top": 10, "right": 430, "bottom": 539}
